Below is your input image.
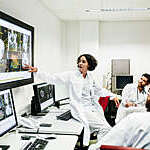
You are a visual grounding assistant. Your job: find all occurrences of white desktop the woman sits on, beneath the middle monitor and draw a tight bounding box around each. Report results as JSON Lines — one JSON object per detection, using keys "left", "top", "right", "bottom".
{"left": 25, "top": 105, "right": 83, "bottom": 135}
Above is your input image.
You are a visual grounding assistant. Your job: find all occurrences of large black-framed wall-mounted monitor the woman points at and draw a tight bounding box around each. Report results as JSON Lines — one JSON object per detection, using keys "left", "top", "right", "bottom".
{"left": 0, "top": 11, "right": 34, "bottom": 90}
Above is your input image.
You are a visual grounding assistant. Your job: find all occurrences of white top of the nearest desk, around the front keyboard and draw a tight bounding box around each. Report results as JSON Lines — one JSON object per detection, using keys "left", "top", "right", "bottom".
{"left": 0, "top": 133, "right": 78, "bottom": 150}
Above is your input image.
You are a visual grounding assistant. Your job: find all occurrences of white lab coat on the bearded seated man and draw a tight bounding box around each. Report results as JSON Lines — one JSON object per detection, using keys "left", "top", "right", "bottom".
{"left": 115, "top": 83, "right": 148, "bottom": 123}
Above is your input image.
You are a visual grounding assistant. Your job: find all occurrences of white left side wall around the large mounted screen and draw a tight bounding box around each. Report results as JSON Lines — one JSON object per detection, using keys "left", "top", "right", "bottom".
{"left": 0, "top": 0, "right": 66, "bottom": 113}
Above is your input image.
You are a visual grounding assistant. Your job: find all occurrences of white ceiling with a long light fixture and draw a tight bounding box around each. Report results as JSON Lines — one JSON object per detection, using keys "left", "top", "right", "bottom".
{"left": 40, "top": 0, "right": 150, "bottom": 21}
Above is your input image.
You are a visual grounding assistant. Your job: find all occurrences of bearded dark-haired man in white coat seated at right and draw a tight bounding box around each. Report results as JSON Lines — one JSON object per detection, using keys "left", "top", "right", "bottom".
{"left": 115, "top": 73, "right": 150, "bottom": 123}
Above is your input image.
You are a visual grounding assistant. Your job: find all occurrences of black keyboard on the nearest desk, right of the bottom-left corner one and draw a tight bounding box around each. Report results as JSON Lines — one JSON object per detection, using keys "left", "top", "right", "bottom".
{"left": 23, "top": 138, "right": 48, "bottom": 150}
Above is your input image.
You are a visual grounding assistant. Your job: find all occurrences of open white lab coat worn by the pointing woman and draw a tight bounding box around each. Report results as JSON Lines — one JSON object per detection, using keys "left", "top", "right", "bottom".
{"left": 36, "top": 70, "right": 115, "bottom": 145}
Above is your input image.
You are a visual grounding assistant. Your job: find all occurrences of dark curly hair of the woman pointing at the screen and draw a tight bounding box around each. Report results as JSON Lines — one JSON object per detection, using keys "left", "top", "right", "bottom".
{"left": 77, "top": 54, "right": 97, "bottom": 71}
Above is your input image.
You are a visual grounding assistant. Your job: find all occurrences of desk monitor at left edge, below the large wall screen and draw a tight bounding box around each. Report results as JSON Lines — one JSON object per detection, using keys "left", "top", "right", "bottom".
{"left": 0, "top": 89, "right": 17, "bottom": 136}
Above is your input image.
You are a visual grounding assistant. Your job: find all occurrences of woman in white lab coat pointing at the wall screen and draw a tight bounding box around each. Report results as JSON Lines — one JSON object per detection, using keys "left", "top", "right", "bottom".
{"left": 26, "top": 54, "right": 118, "bottom": 146}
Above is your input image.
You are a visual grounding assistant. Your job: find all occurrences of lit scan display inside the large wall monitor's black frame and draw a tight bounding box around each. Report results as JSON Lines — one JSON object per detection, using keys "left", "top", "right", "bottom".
{"left": 0, "top": 16, "right": 32, "bottom": 83}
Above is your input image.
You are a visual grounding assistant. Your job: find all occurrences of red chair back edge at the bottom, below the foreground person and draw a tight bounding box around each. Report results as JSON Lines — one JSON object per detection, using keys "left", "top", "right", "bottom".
{"left": 100, "top": 145, "right": 146, "bottom": 150}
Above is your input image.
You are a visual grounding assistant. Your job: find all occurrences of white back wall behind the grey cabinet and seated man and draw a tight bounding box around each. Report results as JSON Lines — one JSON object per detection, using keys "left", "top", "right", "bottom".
{"left": 66, "top": 21, "right": 150, "bottom": 86}
